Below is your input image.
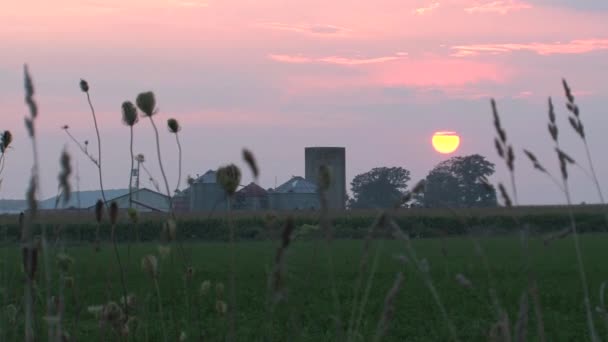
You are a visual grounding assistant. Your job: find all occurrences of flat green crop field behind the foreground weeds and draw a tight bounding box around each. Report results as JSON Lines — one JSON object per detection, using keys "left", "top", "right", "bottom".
{"left": 0, "top": 234, "right": 608, "bottom": 341}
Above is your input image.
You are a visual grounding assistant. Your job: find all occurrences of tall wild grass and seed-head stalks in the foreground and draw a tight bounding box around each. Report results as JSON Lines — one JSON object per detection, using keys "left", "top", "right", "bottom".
{"left": 5, "top": 67, "right": 608, "bottom": 342}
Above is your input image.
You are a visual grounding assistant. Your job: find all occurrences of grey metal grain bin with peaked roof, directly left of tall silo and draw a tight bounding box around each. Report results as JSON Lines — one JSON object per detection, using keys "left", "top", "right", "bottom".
{"left": 268, "top": 176, "right": 320, "bottom": 210}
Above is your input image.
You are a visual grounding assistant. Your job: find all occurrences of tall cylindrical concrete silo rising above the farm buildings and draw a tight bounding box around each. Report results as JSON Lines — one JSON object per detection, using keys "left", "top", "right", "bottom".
{"left": 304, "top": 147, "right": 346, "bottom": 210}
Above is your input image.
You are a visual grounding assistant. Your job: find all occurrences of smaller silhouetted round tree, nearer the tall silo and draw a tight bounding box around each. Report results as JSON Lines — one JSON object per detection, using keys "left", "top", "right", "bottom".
{"left": 349, "top": 167, "right": 410, "bottom": 209}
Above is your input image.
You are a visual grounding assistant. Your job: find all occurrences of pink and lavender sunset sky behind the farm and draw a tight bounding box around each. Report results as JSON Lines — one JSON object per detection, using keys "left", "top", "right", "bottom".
{"left": 0, "top": 0, "right": 608, "bottom": 204}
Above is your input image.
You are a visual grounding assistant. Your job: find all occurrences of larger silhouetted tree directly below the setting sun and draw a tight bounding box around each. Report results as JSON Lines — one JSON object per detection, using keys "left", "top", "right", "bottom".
{"left": 416, "top": 154, "right": 496, "bottom": 208}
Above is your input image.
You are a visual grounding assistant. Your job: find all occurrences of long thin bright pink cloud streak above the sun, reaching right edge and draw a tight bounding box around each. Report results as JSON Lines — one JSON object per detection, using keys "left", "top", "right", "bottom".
{"left": 452, "top": 39, "right": 608, "bottom": 57}
